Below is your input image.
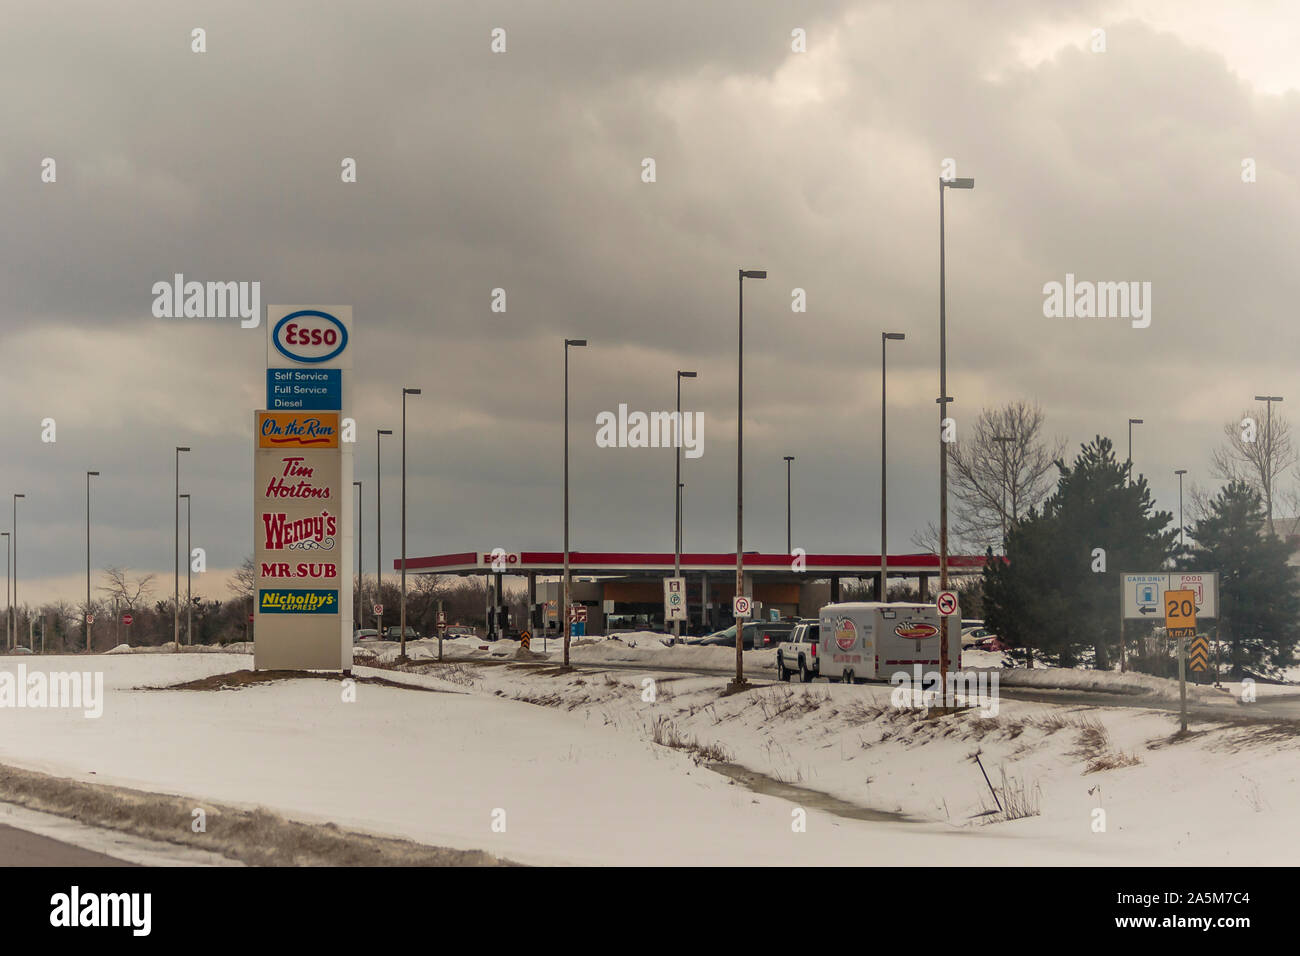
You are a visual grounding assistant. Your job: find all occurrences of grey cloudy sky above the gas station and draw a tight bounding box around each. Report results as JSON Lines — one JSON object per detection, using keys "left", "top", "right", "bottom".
{"left": 0, "top": 0, "right": 1300, "bottom": 601}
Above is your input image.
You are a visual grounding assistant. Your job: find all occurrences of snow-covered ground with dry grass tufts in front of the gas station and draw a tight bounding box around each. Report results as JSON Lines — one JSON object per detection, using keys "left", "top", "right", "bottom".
{"left": 0, "top": 650, "right": 1300, "bottom": 866}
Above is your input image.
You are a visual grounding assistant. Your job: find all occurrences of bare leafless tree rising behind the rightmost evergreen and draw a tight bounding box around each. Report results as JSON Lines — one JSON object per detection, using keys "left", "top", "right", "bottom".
{"left": 1210, "top": 406, "right": 1300, "bottom": 535}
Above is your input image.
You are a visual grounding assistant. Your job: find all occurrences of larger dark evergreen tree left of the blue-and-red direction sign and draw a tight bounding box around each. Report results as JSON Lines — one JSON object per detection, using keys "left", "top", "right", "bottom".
{"left": 984, "top": 436, "right": 1178, "bottom": 669}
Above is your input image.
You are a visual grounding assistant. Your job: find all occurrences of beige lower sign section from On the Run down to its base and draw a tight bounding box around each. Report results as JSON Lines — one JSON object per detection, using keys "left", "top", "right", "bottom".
{"left": 252, "top": 411, "right": 351, "bottom": 670}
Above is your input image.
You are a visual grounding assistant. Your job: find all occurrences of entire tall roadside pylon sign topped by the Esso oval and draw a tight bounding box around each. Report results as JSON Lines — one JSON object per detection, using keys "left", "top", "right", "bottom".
{"left": 252, "top": 306, "right": 355, "bottom": 670}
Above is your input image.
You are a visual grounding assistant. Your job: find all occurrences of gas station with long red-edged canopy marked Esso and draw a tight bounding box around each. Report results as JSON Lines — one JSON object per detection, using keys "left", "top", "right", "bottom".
{"left": 393, "top": 549, "right": 984, "bottom": 635}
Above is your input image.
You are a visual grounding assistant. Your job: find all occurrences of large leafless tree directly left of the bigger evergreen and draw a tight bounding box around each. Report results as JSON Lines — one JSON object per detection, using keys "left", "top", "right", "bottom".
{"left": 948, "top": 402, "right": 1066, "bottom": 550}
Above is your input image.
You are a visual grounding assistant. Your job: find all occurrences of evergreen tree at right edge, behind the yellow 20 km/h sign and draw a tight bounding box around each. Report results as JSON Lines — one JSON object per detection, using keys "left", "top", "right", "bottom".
{"left": 1182, "top": 481, "right": 1300, "bottom": 678}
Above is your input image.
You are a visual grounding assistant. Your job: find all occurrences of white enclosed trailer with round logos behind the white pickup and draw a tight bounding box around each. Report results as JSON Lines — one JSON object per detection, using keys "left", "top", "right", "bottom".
{"left": 816, "top": 601, "right": 962, "bottom": 683}
